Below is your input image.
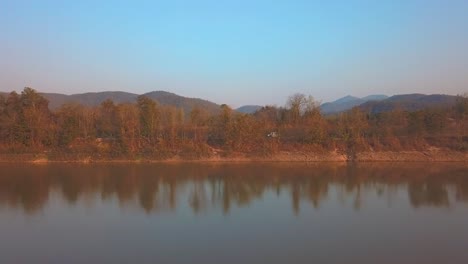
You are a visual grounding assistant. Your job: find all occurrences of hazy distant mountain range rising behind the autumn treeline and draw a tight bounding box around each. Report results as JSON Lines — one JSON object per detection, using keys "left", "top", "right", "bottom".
{"left": 0, "top": 91, "right": 457, "bottom": 115}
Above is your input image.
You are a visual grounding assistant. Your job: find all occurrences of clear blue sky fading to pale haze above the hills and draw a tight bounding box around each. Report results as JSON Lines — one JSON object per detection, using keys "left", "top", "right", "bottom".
{"left": 0, "top": 0, "right": 468, "bottom": 106}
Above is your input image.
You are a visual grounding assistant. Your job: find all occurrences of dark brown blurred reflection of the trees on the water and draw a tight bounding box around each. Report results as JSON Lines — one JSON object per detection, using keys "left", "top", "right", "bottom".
{"left": 0, "top": 163, "right": 468, "bottom": 213}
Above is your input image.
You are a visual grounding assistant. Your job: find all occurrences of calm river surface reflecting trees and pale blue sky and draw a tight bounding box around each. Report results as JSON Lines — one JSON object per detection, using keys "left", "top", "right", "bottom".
{"left": 0, "top": 163, "right": 468, "bottom": 263}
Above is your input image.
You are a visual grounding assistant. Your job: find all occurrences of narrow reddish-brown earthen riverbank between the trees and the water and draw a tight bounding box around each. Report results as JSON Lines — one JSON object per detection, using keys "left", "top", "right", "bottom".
{"left": 0, "top": 148, "right": 468, "bottom": 164}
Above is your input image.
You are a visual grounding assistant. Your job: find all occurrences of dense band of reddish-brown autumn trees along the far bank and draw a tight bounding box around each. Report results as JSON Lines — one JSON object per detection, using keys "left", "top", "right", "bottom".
{"left": 0, "top": 88, "right": 468, "bottom": 160}
